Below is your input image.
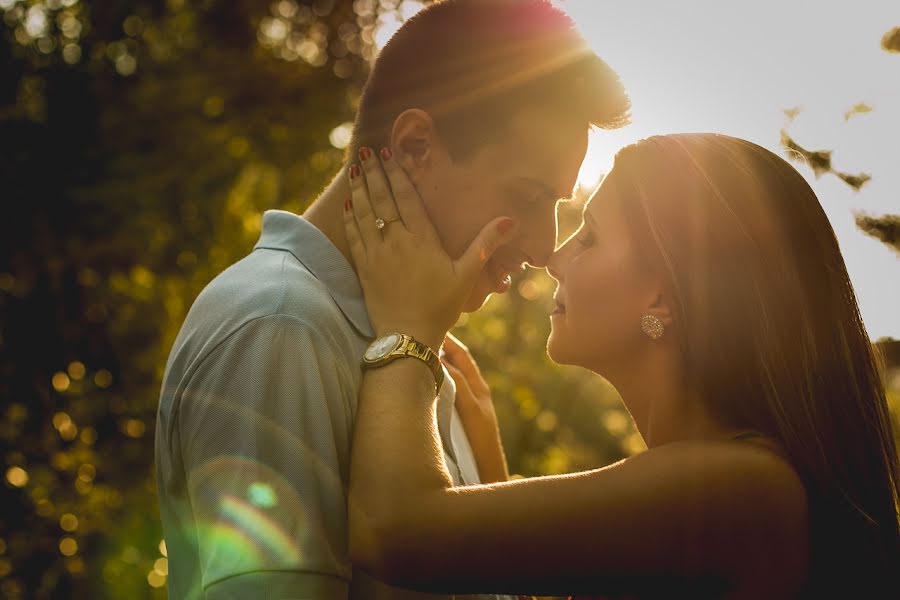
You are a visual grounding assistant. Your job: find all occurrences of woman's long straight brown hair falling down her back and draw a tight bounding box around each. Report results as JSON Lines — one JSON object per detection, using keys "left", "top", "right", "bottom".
{"left": 604, "top": 134, "right": 900, "bottom": 598}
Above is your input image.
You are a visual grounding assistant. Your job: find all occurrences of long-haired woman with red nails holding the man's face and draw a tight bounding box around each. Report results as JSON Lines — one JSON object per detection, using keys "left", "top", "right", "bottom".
{"left": 345, "top": 134, "right": 900, "bottom": 598}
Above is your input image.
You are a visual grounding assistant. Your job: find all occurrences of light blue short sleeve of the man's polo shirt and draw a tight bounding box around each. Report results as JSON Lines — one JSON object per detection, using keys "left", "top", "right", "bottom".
{"left": 179, "top": 314, "right": 354, "bottom": 600}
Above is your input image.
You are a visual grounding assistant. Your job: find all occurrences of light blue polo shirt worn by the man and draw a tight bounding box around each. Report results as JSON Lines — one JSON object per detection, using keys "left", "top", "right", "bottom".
{"left": 156, "top": 210, "right": 506, "bottom": 600}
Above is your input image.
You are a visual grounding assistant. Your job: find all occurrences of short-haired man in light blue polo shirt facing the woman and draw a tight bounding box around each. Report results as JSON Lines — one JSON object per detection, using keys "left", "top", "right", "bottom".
{"left": 156, "top": 0, "right": 629, "bottom": 599}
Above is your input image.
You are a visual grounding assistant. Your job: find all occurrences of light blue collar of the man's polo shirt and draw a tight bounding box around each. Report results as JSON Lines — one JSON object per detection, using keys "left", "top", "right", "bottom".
{"left": 253, "top": 210, "right": 375, "bottom": 339}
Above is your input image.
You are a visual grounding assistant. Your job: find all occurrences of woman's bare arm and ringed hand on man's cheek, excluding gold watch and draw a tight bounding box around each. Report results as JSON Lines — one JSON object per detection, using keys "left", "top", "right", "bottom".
{"left": 345, "top": 151, "right": 805, "bottom": 595}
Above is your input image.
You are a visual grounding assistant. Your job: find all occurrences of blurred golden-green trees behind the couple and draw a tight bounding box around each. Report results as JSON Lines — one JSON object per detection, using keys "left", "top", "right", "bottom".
{"left": 0, "top": 0, "right": 900, "bottom": 599}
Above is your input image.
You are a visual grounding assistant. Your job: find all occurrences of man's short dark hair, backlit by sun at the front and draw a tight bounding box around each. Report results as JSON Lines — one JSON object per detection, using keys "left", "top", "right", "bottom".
{"left": 350, "top": 0, "right": 631, "bottom": 160}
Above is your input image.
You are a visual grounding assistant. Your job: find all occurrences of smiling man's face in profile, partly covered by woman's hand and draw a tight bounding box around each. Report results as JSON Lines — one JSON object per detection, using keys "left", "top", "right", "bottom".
{"left": 416, "top": 109, "right": 587, "bottom": 312}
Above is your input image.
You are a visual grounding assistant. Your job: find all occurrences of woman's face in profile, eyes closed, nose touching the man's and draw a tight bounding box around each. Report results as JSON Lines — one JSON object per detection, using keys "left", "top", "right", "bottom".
{"left": 547, "top": 182, "right": 659, "bottom": 377}
